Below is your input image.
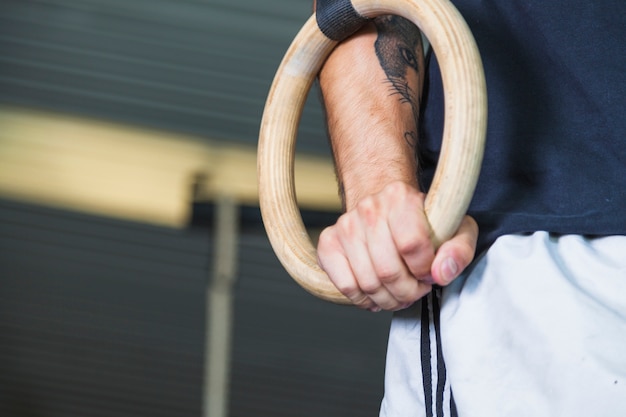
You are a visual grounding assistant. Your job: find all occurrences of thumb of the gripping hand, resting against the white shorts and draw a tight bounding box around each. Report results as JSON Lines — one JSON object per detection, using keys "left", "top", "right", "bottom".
{"left": 431, "top": 216, "right": 478, "bottom": 285}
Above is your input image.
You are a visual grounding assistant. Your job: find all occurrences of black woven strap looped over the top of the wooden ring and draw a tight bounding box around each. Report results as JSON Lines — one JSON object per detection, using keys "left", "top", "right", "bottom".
{"left": 315, "top": 0, "right": 369, "bottom": 41}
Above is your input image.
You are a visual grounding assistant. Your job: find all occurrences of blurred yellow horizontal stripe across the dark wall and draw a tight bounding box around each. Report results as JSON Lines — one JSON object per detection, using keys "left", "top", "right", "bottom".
{"left": 0, "top": 107, "right": 339, "bottom": 227}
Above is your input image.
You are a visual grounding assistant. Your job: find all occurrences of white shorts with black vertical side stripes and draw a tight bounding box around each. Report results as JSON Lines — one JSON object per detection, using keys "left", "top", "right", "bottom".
{"left": 380, "top": 232, "right": 626, "bottom": 417}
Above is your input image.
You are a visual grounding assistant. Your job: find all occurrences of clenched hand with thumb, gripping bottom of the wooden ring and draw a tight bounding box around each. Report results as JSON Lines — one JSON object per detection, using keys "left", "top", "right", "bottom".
{"left": 317, "top": 182, "right": 478, "bottom": 311}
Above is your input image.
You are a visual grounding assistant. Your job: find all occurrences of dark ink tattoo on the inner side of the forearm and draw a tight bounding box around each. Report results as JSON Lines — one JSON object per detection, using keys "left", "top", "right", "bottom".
{"left": 374, "top": 16, "right": 423, "bottom": 149}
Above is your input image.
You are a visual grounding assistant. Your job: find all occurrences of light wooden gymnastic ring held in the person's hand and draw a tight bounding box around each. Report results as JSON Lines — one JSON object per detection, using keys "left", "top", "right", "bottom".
{"left": 257, "top": 0, "right": 487, "bottom": 304}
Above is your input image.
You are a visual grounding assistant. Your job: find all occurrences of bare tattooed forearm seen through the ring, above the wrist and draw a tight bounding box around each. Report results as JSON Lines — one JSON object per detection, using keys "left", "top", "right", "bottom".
{"left": 320, "top": 16, "right": 424, "bottom": 209}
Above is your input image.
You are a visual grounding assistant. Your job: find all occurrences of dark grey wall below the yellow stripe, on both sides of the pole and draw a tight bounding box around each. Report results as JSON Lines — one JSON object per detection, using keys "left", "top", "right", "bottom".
{"left": 0, "top": 200, "right": 389, "bottom": 417}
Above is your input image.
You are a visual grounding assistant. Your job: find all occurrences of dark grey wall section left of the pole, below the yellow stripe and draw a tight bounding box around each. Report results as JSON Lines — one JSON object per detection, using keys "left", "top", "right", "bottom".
{"left": 0, "top": 198, "right": 210, "bottom": 416}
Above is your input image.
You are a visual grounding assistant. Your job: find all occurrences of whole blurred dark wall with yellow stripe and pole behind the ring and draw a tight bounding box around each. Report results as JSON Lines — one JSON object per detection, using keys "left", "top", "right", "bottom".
{"left": 0, "top": 0, "right": 389, "bottom": 417}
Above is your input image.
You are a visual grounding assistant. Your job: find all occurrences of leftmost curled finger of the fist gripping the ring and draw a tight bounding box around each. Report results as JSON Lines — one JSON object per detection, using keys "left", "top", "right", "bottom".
{"left": 317, "top": 227, "right": 376, "bottom": 309}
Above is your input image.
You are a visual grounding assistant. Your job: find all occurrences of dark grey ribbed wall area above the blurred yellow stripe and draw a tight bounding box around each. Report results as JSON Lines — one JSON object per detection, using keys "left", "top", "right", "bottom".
{"left": 0, "top": 0, "right": 329, "bottom": 155}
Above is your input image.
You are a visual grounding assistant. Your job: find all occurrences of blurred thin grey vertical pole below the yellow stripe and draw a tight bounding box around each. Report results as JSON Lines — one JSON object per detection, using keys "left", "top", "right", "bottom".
{"left": 202, "top": 197, "right": 239, "bottom": 417}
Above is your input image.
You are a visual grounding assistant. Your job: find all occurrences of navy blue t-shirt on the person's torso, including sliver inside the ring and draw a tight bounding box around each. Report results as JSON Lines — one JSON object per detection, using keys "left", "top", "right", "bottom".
{"left": 419, "top": 0, "right": 626, "bottom": 250}
